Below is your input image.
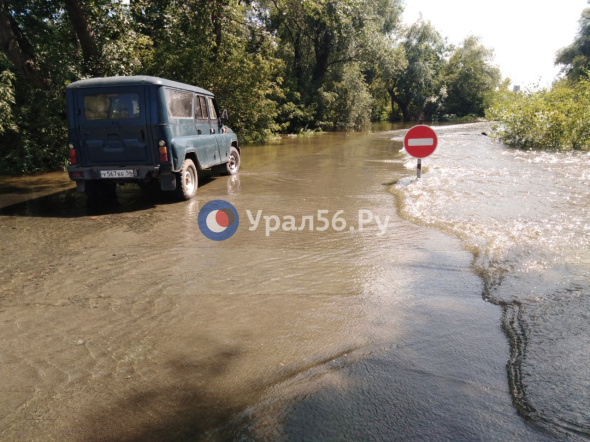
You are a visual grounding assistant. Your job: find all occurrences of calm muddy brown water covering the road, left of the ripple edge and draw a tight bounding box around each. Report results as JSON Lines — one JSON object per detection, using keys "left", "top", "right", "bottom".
{"left": 0, "top": 127, "right": 547, "bottom": 441}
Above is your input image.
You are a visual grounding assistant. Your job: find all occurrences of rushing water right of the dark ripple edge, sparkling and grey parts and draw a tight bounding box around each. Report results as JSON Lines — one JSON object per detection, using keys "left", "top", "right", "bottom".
{"left": 392, "top": 124, "right": 590, "bottom": 434}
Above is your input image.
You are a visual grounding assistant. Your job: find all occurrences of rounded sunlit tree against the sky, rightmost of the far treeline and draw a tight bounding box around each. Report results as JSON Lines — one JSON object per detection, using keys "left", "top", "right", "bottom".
{"left": 441, "top": 36, "right": 502, "bottom": 117}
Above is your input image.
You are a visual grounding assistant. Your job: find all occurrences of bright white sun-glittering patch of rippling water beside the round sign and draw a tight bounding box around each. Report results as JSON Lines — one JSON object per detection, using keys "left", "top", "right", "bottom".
{"left": 395, "top": 125, "right": 590, "bottom": 300}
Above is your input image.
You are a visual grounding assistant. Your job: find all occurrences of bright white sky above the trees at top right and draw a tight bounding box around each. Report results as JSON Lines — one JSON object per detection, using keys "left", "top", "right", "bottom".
{"left": 403, "top": 0, "right": 590, "bottom": 89}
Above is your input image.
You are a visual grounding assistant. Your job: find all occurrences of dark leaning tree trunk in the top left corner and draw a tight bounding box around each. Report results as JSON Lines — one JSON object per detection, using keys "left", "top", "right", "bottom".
{"left": 0, "top": 8, "right": 50, "bottom": 89}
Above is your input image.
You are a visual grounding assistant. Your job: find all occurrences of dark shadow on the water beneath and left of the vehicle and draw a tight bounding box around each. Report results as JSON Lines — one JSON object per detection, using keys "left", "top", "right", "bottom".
{"left": 0, "top": 176, "right": 216, "bottom": 218}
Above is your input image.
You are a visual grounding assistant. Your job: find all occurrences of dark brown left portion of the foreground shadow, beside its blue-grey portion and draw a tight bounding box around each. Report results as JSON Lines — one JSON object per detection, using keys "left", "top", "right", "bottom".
{"left": 72, "top": 346, "right": 255, "bottom": 442}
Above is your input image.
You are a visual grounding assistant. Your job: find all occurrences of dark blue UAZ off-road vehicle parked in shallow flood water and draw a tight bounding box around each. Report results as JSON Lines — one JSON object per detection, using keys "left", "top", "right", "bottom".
{"left": 66, "top": 76, "right": 240, "bottom": 199}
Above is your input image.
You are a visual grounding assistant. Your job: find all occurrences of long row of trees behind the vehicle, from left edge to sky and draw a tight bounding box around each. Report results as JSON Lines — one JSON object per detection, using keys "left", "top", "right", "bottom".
{"left": 0, "top": 0, "right": 507, "bottom": 174}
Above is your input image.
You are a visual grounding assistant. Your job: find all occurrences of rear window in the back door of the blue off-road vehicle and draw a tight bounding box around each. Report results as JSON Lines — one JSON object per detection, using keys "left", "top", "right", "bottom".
{"left": 84, "top": 93, "right": 141, "bottom": 120}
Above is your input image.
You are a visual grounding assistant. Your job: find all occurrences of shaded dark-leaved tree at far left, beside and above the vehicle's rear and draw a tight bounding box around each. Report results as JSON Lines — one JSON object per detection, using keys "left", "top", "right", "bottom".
{"left": 0, "top": 0, "right": 151, "bottom": 173}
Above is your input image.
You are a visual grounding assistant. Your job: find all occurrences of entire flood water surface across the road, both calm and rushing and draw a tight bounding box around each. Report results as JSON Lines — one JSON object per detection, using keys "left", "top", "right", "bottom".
{"left": 0, "top": 124, "right": 590, "bottom": 441}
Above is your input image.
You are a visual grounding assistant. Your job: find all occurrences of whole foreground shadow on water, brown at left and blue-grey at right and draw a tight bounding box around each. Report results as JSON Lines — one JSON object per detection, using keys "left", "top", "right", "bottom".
{"left": 79, "top": 348, "right": 554, "bottom": 442}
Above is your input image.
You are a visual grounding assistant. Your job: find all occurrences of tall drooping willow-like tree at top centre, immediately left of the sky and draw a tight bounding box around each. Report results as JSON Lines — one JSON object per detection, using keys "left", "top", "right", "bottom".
{"left": 260, "top": 0, "right": 401, "bottom": 130}
